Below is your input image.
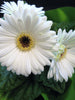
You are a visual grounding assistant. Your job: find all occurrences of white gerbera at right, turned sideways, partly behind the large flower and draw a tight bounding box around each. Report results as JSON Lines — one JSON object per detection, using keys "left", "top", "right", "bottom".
{"left": 47, "top": 29, "right": 75, "bottom": 82}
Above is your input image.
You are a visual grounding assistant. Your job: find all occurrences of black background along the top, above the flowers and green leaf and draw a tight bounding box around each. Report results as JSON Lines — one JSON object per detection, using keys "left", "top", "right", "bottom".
{"left": 0, "top": 0, "right": 75, "bottom": 10}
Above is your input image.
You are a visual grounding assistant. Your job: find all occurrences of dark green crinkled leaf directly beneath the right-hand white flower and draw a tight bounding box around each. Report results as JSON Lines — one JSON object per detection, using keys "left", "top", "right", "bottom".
{"left": 36, "top": 66, "right": 65, "bottom": 93}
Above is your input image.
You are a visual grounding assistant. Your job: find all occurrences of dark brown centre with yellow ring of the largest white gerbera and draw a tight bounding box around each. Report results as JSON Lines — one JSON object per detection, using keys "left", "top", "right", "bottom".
{"left": 17, "top": 33, "right": 34, "bottom": 51}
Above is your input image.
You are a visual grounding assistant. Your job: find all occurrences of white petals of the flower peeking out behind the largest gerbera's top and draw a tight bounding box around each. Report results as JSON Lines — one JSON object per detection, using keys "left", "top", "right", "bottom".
{"left": 1, "top": 0, "right": 45, "bottom": 16}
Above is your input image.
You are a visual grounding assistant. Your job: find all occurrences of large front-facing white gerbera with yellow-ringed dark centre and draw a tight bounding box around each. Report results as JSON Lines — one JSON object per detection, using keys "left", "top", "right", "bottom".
{"left": 0, "top": 3, "right": 56, "bottom": 76}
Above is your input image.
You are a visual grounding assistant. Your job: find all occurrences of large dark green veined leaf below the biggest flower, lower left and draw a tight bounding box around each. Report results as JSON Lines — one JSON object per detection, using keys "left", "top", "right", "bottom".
{"left": 0, "top": 66, "right": 42, "bottom": 100}
